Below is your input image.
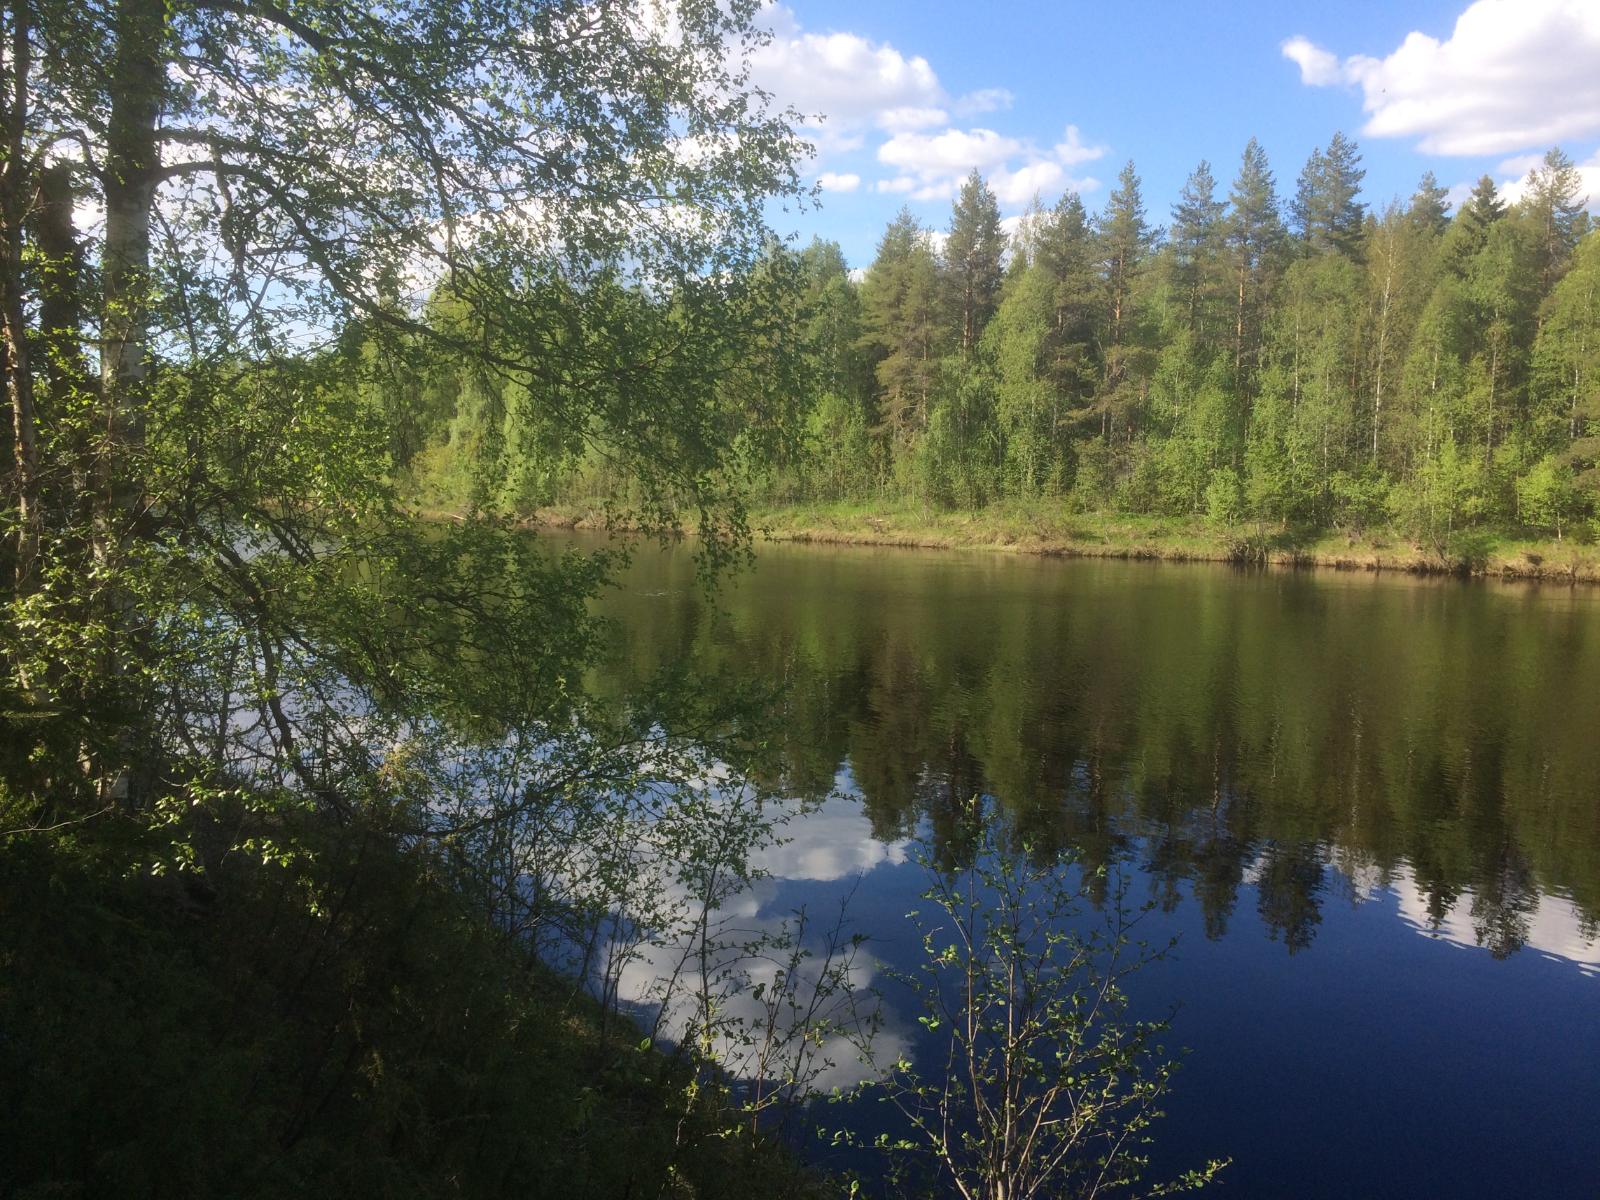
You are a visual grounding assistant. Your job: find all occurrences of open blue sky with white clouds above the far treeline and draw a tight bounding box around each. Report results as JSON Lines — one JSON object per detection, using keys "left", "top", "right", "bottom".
{"left": 754, "top": 0, "right": 1600, "bottom": 266}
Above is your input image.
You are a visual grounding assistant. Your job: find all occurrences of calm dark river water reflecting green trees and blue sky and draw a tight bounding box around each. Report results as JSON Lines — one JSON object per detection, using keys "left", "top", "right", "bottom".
{"left": 582, "top": 546, "right": 1600, "bottom": 1197}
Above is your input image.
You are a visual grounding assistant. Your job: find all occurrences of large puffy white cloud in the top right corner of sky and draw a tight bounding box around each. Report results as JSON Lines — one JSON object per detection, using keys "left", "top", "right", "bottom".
{"left": 1282, "top": 0, "right": 1600, "bottom": 155}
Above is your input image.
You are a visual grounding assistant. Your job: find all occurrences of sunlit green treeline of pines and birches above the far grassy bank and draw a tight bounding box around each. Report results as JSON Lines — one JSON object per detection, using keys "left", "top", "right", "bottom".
{"left": 390, "top": 134, "right": 1600, "bottom": 549}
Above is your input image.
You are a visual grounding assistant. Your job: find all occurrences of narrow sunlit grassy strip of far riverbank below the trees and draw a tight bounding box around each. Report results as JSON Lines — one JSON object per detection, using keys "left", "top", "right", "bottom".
{"left": 531, "top": 502, "right": 1600, "bottom": 582}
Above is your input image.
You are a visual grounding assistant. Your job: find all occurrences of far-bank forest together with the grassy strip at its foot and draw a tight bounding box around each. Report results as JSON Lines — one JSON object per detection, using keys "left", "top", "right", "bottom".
{"left": 403, "top": 151, "right": 1600, "bottom": 598}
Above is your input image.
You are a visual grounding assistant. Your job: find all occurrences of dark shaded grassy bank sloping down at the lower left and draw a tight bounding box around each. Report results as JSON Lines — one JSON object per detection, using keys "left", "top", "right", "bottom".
{"left": 0, "top": 803, "right": 824, "bottom": 1200}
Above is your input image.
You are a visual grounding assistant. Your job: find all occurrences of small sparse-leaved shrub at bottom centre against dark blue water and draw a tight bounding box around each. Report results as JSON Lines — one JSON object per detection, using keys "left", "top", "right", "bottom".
{"left": 838, "top": 806, "right": 1221, "bottom": 1200}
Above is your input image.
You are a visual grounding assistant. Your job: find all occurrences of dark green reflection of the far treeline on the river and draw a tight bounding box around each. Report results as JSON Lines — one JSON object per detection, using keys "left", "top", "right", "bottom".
{"left": 585, "top": 546, "right": 1600, "bottom": 968}
